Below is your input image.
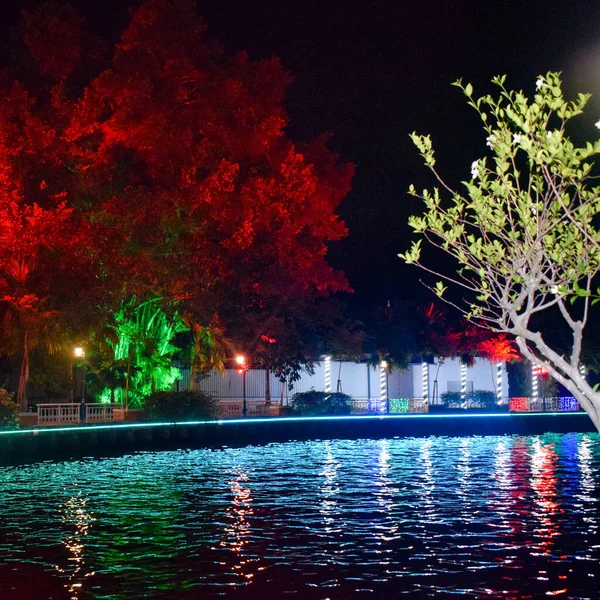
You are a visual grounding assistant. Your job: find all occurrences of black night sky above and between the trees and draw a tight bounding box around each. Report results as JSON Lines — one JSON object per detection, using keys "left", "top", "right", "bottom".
{"left": 0, "top": 0, "right": 600, "bottom": 314}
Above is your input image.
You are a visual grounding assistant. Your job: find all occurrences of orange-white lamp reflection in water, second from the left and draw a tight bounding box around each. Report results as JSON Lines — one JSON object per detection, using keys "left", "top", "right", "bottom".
{"left": 220, "top": 468, "right": 260, "bottom": 586}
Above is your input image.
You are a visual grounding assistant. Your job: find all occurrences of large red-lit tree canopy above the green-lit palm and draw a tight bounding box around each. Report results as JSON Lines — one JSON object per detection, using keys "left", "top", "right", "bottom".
{"left": 0, "top": 0, "right": 353, "bottom": 404}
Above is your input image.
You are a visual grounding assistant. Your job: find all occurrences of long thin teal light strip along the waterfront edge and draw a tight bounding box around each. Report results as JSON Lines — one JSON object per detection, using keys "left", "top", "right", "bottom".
{"left": 0, "top": 412, "right": 587, "bottom": 435}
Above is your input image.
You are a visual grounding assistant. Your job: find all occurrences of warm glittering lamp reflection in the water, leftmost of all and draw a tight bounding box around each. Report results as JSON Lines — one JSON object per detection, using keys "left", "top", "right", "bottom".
{"left": 56, "top": 494, "right": 96, "bottom": 600}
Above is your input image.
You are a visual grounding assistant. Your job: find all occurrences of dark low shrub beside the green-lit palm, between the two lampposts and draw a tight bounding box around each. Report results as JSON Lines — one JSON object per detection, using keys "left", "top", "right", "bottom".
{"left": 144, "top": 390, "right": 217, "bottom": 421}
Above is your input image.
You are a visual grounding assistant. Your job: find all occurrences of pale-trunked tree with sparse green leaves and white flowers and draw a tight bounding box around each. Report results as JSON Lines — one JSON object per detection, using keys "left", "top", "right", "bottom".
{"left": 400, "top": 73, "right": 600, "bottom": 430}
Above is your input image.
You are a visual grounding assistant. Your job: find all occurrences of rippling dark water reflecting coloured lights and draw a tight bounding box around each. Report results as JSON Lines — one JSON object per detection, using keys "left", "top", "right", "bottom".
{"left": 0, "top": 434, "right": 600, "bottom": 599}
